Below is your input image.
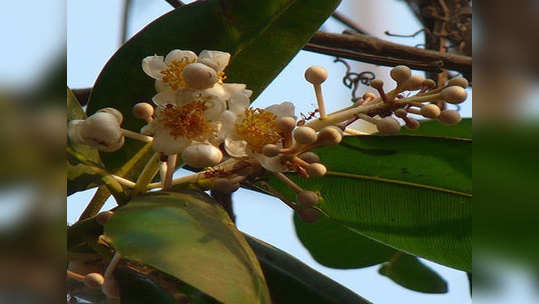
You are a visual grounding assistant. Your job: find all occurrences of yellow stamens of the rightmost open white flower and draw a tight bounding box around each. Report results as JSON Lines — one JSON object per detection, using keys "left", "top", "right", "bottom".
{"left": 236, "top": 109, "right": 282, "bottom": 153}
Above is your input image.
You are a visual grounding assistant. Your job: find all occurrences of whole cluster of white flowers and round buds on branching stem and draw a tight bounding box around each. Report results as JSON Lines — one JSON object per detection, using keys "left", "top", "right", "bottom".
{"left": 69, "top": 50, "right": 468, "bottom": 221}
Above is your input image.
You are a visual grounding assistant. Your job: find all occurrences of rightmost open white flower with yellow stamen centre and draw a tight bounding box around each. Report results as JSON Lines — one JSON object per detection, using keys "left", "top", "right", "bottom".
{"left": 220, "top": 98, "right": 294, "bottom": 172}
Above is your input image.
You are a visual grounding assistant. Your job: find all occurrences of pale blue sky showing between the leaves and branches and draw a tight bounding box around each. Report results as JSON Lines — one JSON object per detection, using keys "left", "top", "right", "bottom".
{"left": 67, "top": 0, "right": 471, "bottom": 304}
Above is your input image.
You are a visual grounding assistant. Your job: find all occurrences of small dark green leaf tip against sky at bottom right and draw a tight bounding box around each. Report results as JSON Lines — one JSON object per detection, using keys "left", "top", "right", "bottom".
{"left": 378, "top": 253, "right": 447, "bottom": 293}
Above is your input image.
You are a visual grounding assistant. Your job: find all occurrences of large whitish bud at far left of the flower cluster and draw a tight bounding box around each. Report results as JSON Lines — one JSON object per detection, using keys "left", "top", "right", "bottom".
{"left": 79, "top": 112, "right": 124, "bottom": 152}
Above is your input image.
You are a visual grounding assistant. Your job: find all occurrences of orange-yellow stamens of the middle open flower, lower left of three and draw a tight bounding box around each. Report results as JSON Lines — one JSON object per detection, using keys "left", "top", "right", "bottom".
{"left": 158, "top": 101, "right": 216, "bottom": 140}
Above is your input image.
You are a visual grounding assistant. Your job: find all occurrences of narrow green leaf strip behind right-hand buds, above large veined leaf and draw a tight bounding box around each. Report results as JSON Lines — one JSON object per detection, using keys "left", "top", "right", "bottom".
{"left": 400, "top": 118, "right": 472, "bottom": 139}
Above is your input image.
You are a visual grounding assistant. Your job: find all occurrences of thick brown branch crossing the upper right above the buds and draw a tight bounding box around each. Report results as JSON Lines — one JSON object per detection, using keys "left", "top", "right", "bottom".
{"left": 307, "top": 32, "right": 472, "bottom": 77}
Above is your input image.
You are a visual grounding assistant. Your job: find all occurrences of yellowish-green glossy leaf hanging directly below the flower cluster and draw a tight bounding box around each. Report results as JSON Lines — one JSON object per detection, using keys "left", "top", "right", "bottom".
{"left": 105, "top": 191, "right": 271, "bottom": 304}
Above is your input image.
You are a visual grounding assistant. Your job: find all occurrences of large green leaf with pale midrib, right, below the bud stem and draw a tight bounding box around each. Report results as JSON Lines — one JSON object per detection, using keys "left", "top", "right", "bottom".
{"left": 270, "top": 135, "right": 472, "bottom": 270}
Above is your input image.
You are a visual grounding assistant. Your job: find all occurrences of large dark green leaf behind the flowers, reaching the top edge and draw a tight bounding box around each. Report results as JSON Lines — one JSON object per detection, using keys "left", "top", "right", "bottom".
{"left": 88, "top": 0, "right": 340, "bottom": 171}
